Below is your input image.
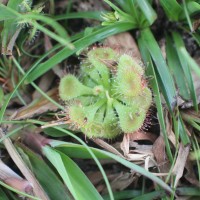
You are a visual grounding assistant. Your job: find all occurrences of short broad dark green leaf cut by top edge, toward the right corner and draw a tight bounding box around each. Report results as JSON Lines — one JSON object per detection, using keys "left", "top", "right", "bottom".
{"left": 160, "top": 0, "right": 182, "bottom": 21}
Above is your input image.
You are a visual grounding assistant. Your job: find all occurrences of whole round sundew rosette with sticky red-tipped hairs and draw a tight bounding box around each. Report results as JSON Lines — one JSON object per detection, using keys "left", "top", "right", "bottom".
{"left": 59, "top": 47, "right": 152, "bottom": 139}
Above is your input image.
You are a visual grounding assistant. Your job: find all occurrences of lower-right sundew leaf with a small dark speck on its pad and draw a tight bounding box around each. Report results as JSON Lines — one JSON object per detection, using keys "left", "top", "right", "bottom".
{"left": 113, "top": 101, "right": 146, "bottom": 133}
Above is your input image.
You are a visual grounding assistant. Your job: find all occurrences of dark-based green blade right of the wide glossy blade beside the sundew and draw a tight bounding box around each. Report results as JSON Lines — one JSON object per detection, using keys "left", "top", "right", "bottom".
{"left": 166, "top": 36, "right": 190, "bottom": 100}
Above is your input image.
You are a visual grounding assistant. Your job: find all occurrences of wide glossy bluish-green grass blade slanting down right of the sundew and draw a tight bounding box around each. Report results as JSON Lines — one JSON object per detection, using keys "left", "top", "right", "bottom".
{"left": 141, "top": 28, "right": 176, "bottom": 112}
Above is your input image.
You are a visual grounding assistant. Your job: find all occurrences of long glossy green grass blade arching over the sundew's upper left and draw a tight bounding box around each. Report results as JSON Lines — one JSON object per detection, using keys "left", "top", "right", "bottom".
{"left": 27, "top": 23, "right": 134, "bottom": 83}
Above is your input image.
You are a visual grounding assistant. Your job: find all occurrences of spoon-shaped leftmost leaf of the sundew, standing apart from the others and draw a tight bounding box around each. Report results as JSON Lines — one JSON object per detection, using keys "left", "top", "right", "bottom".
{"left": 59, "top": 75, "right": 93, "bottom": 100}
